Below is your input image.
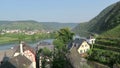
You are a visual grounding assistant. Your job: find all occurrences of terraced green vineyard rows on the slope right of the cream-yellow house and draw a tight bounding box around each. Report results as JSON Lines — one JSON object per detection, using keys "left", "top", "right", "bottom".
{"left": 89, "top": 37, "right": 120, "bottom": 68}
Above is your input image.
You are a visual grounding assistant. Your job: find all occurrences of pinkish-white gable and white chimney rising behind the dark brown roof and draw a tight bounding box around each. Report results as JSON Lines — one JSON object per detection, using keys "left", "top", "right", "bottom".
{"left": 13, "top": 42, "right": 36, "bottom": 68}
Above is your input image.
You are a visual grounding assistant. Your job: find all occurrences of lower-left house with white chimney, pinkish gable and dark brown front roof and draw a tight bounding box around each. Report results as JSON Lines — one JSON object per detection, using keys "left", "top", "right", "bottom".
{"left": 0, "top": 42, "right": 36, "bottom": 68}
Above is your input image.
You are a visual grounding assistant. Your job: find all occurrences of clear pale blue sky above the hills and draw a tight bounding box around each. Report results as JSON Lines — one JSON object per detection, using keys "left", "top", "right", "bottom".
{"left": 0, "top": 0, "right": 120, "bottom": 23}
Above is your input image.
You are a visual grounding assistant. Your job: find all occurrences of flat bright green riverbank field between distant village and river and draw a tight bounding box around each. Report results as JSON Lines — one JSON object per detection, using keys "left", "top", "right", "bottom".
{"left": 0, "top": 33, "right": 53, "bottom": 44}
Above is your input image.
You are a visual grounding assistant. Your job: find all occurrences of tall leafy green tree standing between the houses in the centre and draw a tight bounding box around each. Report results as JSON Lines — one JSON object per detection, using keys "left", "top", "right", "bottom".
{"left": 52, "top": 28, "right": 74, "bottom": 68}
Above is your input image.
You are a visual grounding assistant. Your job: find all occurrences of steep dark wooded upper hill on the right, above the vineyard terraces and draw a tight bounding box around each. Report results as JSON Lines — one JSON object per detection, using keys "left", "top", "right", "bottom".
{"left": 73, "top": 2, "right": 120, "bottom": 36}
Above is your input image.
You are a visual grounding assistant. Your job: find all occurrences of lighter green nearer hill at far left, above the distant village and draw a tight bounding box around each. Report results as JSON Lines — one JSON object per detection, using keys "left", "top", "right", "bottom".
{"left": 0, "top": 21, "right": 43, "bottom": 30}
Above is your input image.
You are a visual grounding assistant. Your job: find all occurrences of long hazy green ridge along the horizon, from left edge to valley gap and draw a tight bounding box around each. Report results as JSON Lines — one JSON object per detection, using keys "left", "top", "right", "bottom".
{"left": 0, "top": 20, "right": 77, "bottom": 30}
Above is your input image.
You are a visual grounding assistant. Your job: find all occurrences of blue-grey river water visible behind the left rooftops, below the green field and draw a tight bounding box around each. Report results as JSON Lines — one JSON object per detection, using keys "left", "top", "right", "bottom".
{"left": 0, "top": 39, "right": 53, "bottom": 50}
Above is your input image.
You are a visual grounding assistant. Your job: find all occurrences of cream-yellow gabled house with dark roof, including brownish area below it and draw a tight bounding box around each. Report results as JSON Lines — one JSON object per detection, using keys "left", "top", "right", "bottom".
{"left": 67, "top": 38, "right": 90, "bottom": 68}
